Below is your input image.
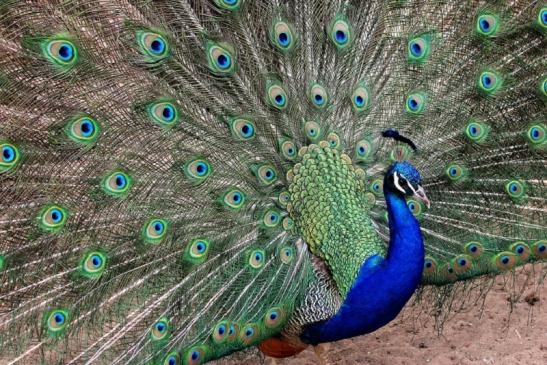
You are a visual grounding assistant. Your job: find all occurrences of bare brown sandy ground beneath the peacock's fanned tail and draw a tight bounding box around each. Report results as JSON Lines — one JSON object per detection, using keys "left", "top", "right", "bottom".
{"left": 215, "top": 268, "right": 547, "bottom": 365}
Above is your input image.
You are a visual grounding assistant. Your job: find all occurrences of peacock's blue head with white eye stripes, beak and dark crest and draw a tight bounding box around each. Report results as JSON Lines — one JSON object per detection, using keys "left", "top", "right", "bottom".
{"left": 382, "top": 129, "right": 431, "bottom": 208}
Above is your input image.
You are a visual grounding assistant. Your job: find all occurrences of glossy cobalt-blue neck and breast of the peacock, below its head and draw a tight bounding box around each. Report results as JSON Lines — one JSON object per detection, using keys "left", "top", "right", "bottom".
{"left": 301, "top": 184, "right": 424, "bottom": 344}
